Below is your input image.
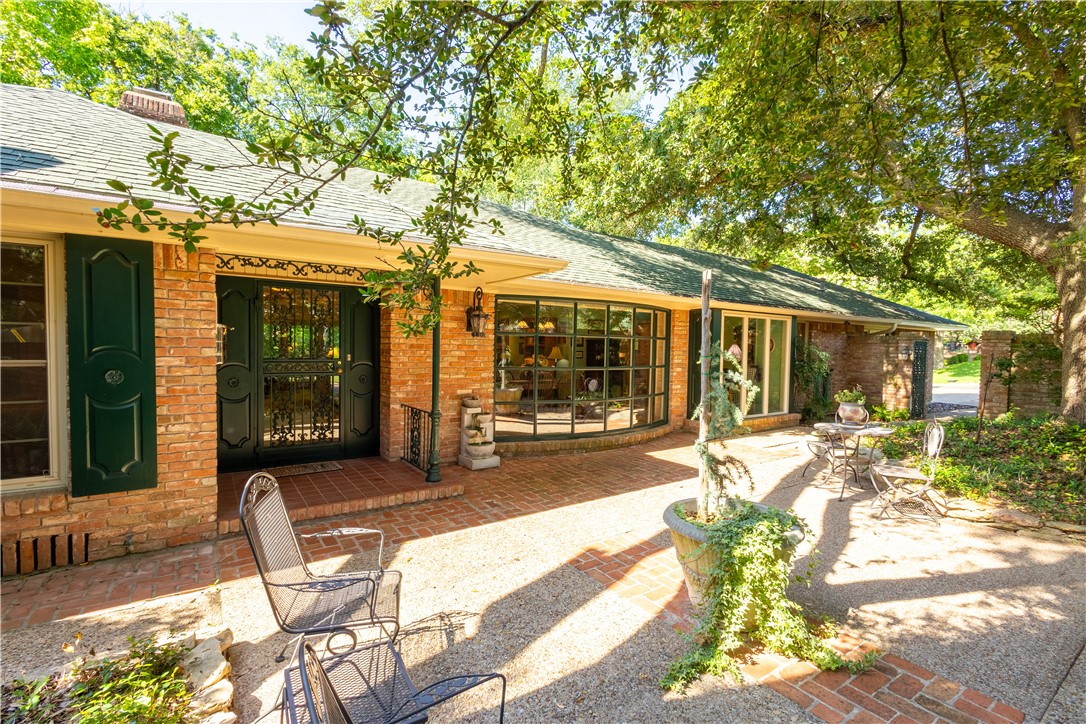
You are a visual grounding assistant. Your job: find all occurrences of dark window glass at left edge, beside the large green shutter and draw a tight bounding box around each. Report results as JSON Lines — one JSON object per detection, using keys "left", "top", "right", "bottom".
{"left": 0, "top": 243, "right": 51, "bottom": 480}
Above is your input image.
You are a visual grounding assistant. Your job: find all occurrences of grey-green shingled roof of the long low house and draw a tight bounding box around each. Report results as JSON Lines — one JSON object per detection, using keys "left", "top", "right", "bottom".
{"left": 0, "top": 86, "right": 960, "bottom": 328}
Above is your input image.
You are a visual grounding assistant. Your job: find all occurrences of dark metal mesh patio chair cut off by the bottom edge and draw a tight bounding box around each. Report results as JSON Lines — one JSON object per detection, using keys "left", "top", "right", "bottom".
{"left": 285, "top": 640, "right": 505, "bottom": 724}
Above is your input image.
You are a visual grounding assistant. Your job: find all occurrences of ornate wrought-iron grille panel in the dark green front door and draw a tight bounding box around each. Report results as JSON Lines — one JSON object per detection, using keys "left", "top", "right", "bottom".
{"left": 261, "top": 285, "right": 343, "bottom": 452}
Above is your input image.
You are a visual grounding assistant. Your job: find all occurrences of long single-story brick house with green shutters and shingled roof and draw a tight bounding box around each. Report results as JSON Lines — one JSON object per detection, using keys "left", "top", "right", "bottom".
{"left": 0, "top": 86, "right": 960, "bottom": 574}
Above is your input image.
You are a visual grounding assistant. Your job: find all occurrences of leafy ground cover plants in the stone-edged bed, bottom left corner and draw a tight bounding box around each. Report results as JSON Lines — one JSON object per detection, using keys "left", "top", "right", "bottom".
{"left": 0, "top": 637, "right": 195, "bottom": 724}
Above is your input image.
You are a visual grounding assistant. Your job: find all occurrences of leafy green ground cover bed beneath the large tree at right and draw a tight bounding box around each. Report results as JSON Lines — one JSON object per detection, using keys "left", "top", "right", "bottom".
{"left": 883, "top": 415, "right": 1086, "bottom": 524}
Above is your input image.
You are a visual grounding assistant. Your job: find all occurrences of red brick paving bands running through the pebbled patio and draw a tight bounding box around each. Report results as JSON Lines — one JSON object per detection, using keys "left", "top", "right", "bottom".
{"left": 0, "top": 434, "right": 1024, "bottom": 724}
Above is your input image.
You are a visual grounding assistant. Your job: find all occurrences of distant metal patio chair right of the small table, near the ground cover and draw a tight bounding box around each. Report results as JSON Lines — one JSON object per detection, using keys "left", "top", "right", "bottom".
{"left": 871, "top": 422, "right": 946, "bottom": 520}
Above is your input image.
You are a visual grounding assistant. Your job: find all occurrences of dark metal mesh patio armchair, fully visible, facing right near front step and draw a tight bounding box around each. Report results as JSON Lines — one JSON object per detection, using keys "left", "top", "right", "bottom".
{"left": 241, "top": 472, "right": 402, "bottom": 661}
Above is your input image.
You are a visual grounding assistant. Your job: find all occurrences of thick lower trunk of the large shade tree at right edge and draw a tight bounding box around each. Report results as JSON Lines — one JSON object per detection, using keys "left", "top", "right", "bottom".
{"left": 1052, "top": 253, "right": 1086, "bottom": 424}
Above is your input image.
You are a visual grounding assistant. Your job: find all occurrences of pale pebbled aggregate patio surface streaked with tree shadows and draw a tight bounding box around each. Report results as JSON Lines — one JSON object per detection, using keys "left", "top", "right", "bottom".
{"left": 3, "top": 429, "right": 1086, "bottom": 722}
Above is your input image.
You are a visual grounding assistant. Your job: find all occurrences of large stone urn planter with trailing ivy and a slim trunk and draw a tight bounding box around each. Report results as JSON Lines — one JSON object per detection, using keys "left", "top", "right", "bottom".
{"left": 660, "top": 303, "right": 875, "bottom": 691}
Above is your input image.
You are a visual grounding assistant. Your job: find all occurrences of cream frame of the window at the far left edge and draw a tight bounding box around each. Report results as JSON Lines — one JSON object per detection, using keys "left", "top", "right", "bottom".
{"left": 0, "top": 231, "right": 68, "bottom": 495}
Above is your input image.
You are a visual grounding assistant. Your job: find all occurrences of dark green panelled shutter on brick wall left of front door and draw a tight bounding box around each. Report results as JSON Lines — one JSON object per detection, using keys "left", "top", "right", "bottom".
{"left": 66, "top": 237, "right": 157, "bottom": 496}
